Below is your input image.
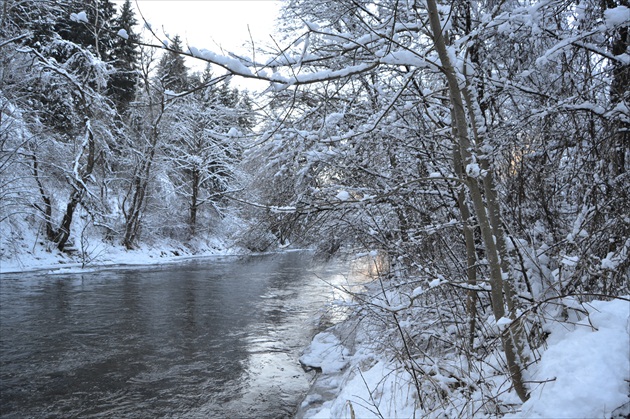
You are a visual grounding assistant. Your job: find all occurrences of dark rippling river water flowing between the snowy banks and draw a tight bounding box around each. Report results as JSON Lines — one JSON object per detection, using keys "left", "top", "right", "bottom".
{"left": 0, "top": 253, "right": 356, "bottom": 418}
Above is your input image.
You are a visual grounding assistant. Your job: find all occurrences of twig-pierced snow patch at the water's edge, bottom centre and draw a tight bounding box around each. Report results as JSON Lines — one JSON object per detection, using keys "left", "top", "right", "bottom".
{"left": 296, "top": 319, "right": 416, "bottom": 418}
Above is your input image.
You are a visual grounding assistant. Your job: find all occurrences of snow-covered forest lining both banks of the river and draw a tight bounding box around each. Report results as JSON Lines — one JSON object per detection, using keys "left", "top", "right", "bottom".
{"left": 0, "top": 0, "right": 630, "bottom": 417}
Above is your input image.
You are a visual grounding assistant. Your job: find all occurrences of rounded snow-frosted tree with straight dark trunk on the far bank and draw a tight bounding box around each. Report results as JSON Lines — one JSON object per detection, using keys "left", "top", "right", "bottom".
{"left": 163, "top": 71, "right": 251, "bottom": 236}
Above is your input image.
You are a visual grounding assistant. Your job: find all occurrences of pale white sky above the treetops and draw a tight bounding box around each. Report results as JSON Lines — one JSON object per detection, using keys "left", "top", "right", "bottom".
{"left": 114, "top": 0, "right": 282, "bottom": 87}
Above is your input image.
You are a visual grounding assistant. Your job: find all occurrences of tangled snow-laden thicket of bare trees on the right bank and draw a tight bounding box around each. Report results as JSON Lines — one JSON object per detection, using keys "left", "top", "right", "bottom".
{"left": 146, "top": 0, "right": 630, "bottom": 410}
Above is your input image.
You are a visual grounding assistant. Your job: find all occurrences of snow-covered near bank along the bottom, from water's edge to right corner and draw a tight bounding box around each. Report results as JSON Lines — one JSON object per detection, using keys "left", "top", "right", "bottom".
{"left": 298, "top": 297, "right": 630, "bottom": 418}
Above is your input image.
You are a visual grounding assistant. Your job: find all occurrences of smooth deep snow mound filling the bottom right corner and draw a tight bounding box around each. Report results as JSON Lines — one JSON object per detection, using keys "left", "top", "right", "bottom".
{"left": 516, "top": 299, "right": 630, "bottom": 418}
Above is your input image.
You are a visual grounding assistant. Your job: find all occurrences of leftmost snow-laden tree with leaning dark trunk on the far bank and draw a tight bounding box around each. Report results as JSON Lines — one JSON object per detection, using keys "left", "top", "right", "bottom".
{"left": 1, "top": 2, "right": 119, "bottom": 250}
